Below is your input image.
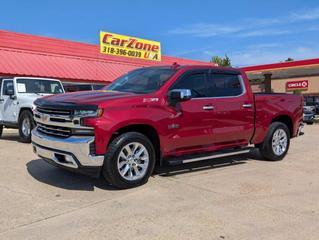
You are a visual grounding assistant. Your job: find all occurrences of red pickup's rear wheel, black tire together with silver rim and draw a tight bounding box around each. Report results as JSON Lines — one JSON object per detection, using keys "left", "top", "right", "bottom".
{"left": 258, "top": 122, "right": 290, "bottom": 161}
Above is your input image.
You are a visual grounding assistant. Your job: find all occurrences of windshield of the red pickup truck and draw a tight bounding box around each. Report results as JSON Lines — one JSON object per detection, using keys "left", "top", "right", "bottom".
{"left": 104, "top": 68, "right": 176, "bottom": 93}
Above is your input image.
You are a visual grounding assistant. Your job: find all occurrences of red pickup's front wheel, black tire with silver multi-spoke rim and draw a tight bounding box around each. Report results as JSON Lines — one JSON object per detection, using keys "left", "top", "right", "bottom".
{"left": 102, "top": 132, "right": 156, "bottom": 189}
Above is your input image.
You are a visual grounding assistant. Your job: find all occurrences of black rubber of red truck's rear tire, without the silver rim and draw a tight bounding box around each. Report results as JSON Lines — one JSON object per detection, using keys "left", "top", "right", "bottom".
{"left": 260, "top": 122, "right": 290, "bottom": 161}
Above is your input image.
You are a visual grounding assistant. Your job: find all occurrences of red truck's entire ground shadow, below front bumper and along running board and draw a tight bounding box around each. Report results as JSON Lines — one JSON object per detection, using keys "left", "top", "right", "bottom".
{"left": 26, "top": 150, "right": 262, "bottom": 191}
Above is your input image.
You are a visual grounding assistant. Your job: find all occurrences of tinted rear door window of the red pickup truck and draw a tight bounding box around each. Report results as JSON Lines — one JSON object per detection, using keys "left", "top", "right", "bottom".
{"left": 207, "top": 73, "right": 243, "bottom": 97}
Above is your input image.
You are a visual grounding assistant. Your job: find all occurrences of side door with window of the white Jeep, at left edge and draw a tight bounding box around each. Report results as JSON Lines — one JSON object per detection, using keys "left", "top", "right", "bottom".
{"left": 0, "top": 79, "right": 17, "bottom": 122}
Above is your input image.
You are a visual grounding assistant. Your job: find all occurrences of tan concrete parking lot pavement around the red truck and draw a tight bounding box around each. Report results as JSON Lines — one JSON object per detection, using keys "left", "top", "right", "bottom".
{"left": 0, "top": 125, "right": 319, "bottom": 240}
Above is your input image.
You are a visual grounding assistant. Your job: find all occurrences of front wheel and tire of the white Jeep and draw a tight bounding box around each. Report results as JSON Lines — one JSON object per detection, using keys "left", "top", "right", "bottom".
{"left": 18, "top": 110, "right": 35, "bottom": 143}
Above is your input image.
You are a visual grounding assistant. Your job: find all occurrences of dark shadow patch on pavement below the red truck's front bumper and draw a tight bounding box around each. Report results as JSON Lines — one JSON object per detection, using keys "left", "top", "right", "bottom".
{"left": 26, "top": 159, "right": 116, "bottom": 191}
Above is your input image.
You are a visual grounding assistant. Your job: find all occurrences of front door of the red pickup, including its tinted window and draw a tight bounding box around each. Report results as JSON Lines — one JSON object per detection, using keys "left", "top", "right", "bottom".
{"left": 166, "top": 70, "right": 213, "bottom": 154}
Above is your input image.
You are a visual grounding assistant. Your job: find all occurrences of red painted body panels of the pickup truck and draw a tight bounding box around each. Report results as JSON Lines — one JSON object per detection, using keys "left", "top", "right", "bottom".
{"left": 41, "top": 65, "right": 303, "bottom": 156}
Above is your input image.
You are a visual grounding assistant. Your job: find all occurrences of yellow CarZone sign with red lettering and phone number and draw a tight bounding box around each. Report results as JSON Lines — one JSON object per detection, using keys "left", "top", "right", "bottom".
{"left": 100, "top": 31, "right": 161, "bottom": 61}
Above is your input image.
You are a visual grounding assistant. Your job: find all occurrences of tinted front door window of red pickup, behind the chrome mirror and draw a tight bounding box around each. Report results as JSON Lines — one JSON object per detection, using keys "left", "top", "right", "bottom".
{"left": 170, "top": 72, "right": 207, "bottom": 98}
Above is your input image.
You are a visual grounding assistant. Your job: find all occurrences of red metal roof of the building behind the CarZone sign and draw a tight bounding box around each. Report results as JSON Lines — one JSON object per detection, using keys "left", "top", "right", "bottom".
{"left": 0, "top": 30, "right": 207, "bottom": 82}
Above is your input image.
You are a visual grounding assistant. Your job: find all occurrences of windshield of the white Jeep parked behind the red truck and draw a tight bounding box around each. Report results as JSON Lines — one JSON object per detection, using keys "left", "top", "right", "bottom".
{"left": 17, "top": 79, "right": 63, "bottom": 94}
